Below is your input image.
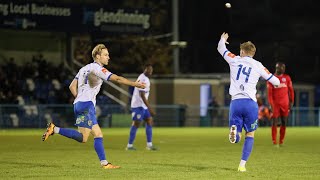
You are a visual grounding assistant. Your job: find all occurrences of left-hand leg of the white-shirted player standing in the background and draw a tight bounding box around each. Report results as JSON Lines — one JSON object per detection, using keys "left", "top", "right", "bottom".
{"left": 126, "top": 108, "right": 143, "bottom": 150}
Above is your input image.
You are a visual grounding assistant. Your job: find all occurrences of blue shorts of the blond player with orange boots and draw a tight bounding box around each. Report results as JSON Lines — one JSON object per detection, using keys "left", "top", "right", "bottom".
{"left": 74, "top": 101, "right": 98, "bottom": 129}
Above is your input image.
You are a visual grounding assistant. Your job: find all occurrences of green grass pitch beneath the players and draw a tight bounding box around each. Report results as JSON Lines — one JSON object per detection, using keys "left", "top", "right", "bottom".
{"left": 0, "top": 127, "right": 320, "bottom": 180}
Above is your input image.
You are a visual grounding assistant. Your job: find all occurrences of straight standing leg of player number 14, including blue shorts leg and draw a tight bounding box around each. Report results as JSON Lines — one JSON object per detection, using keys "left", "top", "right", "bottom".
{"left": 238, "top": 99, "right": 258, "bottom": 172}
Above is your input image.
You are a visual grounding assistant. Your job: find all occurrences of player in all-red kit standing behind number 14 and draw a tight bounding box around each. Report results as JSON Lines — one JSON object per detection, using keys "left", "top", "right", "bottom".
{"left": 268, "top": 62, "right": 294, "bottom": 146}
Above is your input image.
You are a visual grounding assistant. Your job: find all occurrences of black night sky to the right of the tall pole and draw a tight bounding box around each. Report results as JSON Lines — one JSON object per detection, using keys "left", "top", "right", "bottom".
{"left": 180, "top": 0, "right": 320, "bottom": 83}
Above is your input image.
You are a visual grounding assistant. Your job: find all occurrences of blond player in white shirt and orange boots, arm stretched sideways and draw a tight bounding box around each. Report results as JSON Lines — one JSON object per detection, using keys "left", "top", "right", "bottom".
{"left": 42, "top": 44, "right": 145, "bottom": 169}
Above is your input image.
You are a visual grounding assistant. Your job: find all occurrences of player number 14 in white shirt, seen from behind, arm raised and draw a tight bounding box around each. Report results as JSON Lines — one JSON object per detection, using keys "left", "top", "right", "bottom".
{"left": 217, "top": 33, "right": 280, "bottom": 172}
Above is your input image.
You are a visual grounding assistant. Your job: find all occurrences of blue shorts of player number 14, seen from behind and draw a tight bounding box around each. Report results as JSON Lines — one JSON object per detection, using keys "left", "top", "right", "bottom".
{"left": 229, "top": 99, "right": 258, "bottom": 132}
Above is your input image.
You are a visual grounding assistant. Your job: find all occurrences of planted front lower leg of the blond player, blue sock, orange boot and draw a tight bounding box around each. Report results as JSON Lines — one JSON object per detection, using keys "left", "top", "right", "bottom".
{"left": 91, "top": 123, "right": 120, "bottom": 169}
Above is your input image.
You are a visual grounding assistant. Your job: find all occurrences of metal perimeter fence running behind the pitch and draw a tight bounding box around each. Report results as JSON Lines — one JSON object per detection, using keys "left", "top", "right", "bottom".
{"left": 0, "top": 104, "right": 320, "bottom": 128}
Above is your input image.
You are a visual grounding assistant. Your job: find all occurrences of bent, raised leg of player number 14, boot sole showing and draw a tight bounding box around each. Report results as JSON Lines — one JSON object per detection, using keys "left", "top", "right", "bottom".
{"left": 229, "top": 100, "right": 243, "bottom": 143}
